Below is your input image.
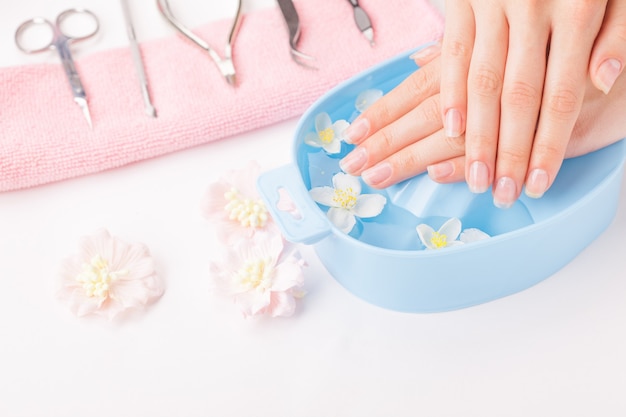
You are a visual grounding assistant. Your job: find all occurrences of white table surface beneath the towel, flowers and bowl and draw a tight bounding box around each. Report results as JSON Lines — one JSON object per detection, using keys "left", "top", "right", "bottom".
{"left": 0, "top": 0, "right": 626, "bottom": 417}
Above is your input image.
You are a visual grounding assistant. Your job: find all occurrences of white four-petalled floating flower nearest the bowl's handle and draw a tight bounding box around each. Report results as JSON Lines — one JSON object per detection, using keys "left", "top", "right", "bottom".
{"left": 309, "top": 172, "right": 387, "bottom": 233}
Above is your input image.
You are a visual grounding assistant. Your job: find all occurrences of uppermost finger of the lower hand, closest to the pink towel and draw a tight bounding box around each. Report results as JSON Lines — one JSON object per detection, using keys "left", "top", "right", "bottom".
{"left": 345, "top": 54, "right": 441, "bottom": 145}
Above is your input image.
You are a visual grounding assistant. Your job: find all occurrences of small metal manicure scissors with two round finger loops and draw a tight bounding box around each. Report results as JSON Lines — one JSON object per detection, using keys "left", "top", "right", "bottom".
{"left": 15, "top": 9, "right": 100, "bottom": 128}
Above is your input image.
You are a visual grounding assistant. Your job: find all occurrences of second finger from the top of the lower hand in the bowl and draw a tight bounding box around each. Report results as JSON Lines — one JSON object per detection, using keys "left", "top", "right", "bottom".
{"left": 339, "top": 95, "right": 442, "bottom": 175}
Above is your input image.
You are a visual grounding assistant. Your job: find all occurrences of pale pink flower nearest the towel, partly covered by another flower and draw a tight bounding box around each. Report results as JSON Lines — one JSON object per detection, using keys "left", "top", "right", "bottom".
{"left": 202, "top": 162, "right": 278, "bottom": 243}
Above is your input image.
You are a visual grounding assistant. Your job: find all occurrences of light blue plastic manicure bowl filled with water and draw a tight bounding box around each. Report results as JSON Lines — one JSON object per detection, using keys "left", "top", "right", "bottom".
{"left": 258, "top": 48, "right": 626, "bottom": 312}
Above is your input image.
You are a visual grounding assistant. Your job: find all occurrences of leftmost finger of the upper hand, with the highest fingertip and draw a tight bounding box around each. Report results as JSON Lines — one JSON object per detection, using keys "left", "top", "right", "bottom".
{"left": 441, "top": 0, "right": 475, "bottom": 137}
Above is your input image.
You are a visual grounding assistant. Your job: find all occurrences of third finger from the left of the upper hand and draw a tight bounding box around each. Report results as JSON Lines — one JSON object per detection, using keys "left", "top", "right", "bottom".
{"left": 493, "top": 2, "right": 550, "bottom": 208}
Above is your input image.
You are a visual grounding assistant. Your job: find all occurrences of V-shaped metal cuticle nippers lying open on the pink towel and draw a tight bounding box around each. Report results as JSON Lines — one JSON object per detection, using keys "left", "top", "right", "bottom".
{"left": 157, "top": 0, "right": 241, "bottom": 86}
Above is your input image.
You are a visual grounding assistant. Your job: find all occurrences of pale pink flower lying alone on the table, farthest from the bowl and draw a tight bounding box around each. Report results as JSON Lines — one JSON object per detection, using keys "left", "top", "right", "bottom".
{"left": 59, "top": 230, "right": 163, "bottom": 319}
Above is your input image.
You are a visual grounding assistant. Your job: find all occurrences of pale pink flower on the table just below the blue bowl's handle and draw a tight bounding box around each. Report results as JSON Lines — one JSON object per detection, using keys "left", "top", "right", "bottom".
{"left": 210, "top": 234, "right": 305, "bottom": 317}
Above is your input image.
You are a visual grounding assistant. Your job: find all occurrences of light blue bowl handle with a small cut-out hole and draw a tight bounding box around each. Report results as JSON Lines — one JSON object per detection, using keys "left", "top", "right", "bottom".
{"left": 257, "top": 164, "right": 331, "bottom": 245}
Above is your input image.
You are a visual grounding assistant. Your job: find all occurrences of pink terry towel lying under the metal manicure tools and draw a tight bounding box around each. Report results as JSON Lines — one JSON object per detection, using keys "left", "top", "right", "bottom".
{"left": 0, "top": 0, "right": 443, "bottom": 191}
